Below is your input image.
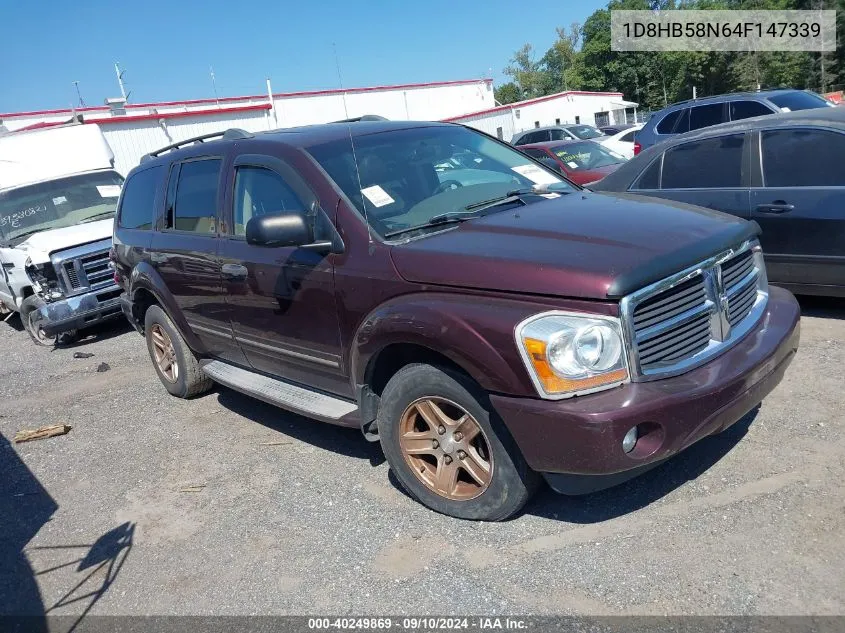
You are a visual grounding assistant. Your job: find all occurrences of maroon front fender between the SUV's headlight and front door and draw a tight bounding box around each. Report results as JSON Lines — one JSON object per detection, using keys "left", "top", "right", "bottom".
{"left": 350, "top": 293, "right": 549, "bottom": 396}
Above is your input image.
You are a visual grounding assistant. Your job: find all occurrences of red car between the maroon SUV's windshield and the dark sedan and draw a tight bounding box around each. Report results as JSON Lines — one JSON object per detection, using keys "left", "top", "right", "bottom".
{"left": 519, "top": 141, "right": 627, "bottom": 185}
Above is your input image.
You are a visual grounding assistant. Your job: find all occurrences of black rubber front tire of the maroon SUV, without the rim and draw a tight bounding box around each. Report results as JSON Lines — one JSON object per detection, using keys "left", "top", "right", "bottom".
{"left": 378, "top": 364, "right": 540, "bottom": 521}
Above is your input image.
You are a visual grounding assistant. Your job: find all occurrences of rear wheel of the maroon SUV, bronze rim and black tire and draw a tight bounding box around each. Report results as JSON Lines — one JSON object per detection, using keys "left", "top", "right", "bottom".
{"left": 144, "top": 305, "right": 214, "bottom": 398}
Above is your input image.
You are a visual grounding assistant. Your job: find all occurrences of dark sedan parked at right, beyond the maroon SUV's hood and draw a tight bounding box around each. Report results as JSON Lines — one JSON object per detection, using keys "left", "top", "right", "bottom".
{"left": 594, "top": 108, "right": 845, "bottom": 296}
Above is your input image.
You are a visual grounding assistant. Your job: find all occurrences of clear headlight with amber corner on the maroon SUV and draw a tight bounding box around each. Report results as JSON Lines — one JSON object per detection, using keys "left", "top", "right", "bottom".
{"left": 516, "top": 312, "right": 628, "bottom": 399}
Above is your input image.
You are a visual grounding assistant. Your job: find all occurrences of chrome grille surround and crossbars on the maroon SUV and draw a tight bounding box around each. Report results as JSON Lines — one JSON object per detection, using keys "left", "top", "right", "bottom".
{"left": 619, "top": 239, "right": 769, "bottom": 382}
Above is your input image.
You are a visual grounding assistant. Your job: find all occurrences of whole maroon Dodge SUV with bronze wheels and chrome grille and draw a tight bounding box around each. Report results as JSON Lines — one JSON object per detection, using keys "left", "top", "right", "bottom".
{"left": 114, "top": 121, "right": 799, "bottom": 520}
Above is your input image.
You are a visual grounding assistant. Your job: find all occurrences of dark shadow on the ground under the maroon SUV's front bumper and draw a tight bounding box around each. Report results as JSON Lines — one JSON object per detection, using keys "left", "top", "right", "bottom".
{"left": 524, "top": 405, "right": 760, "bottom": 524}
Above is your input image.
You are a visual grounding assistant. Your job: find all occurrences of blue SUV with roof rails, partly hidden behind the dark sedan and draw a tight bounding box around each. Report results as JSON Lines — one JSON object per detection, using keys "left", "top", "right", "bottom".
{"left": 634, "top": 89, "right": 833, "bottom": 154}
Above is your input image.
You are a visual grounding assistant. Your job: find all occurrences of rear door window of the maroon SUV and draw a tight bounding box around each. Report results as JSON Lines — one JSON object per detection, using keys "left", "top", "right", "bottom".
{"left": 173, "top": 159, "right": 220, "bottom": 233}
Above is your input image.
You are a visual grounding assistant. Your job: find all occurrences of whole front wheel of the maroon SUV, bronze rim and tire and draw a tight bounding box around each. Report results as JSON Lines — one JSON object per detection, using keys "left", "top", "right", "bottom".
{"left": 378, "top": 365, "right": 539, "bottom": 521}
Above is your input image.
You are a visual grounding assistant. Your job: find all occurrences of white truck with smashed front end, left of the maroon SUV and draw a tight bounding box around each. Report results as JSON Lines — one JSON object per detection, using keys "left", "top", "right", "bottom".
{"left": 0, "top": 124, "right": 123, "bottom": 345}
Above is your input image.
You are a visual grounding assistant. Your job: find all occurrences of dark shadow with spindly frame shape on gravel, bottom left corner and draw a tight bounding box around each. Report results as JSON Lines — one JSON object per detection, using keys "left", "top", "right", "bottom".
{"left": 0, "top": 434, "right": 135, "bottom": 632}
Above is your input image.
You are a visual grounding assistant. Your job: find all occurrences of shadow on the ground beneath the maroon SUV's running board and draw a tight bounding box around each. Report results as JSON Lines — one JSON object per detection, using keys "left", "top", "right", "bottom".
{"left": 216, "top": 385, "right": 384, "bottom": 466}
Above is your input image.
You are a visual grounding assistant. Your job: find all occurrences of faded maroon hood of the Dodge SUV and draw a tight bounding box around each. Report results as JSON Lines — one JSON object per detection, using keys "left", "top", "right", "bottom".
{"left": 391, "top": 191, "right": 760, "bottom": 299}
